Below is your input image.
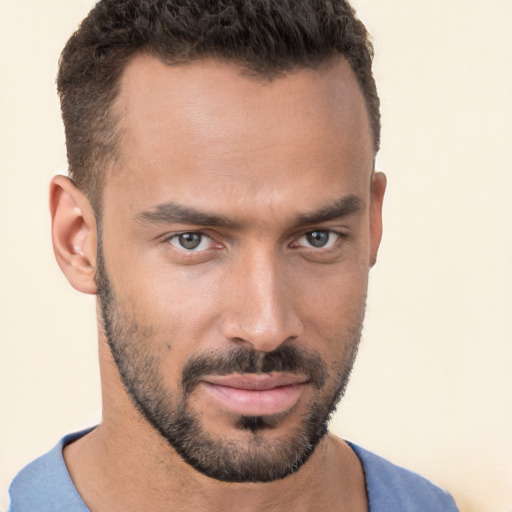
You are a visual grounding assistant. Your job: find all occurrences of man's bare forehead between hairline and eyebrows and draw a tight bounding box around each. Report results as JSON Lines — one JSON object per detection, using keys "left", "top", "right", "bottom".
{"left": 105, "top": 56, "right": 373, "bottom": 220}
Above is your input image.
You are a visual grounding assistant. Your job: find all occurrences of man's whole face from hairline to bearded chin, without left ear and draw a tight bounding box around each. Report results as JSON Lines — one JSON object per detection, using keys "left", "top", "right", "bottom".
{"left": 97, "top": 57, "right": 383, "bottom": 481}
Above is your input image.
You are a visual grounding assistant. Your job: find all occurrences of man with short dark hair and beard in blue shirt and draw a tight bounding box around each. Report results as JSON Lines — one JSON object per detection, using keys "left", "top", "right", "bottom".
{"left": 5, "top": 0, "right": 456, "bottom": 512}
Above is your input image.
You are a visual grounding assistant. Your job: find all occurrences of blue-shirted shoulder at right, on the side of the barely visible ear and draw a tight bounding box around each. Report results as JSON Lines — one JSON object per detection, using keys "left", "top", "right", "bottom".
{"left": 348, "top": 443, "right": 457, "bottom": 512}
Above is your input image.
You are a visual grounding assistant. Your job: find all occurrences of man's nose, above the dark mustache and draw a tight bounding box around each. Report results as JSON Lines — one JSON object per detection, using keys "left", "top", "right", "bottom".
{"left": 222, "top": 247, "right": 303, "bottom": 352}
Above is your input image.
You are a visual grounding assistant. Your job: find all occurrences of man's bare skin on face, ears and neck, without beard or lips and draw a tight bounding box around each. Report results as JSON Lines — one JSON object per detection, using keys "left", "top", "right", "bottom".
{"left": 50, "top": 56, "right": 386, "bottom": 512}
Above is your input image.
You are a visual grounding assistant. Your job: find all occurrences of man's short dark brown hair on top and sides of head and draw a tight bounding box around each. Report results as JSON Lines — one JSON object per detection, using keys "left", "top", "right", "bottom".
{"left": 57, "top": 0, "right": 380, "bottom": 215}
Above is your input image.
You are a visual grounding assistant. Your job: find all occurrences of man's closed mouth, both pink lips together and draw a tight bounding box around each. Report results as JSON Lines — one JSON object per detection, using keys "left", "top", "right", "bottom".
{"left": 201, "top": 373, "right": 308, "bottom": 416}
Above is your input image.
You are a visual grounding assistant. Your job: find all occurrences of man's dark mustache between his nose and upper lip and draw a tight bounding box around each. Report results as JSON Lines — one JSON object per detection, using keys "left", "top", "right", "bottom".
{"left": 182, "top": 345, "right": 328, "bottom": 395}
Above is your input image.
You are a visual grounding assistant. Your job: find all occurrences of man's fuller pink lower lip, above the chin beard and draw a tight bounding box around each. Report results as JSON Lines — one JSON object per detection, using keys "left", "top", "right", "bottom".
{"left": 202, "top": 382, "right": 305, "bottom": 416}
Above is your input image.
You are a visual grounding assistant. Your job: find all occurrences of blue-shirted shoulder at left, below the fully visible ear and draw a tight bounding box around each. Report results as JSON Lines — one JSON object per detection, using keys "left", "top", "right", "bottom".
{"left": 8, "top": 430, "right": 89, "bottom": 512}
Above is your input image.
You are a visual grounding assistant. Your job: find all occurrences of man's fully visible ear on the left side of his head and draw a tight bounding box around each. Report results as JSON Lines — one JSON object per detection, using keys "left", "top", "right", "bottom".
{"left": 50, "top": 176, "right": 97, "bottom": 294}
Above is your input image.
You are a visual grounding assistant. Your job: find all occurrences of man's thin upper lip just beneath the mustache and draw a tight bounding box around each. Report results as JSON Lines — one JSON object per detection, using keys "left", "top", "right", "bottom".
{"left": 203, "top": 373, "right": 308, "bottom": 391}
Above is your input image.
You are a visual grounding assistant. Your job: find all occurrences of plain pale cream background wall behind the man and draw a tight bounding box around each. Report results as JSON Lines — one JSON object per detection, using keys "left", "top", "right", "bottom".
{"left": 0, "top": 0, "right": 512, "bottom": 512}
